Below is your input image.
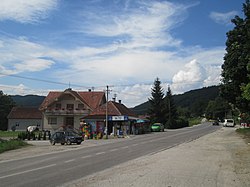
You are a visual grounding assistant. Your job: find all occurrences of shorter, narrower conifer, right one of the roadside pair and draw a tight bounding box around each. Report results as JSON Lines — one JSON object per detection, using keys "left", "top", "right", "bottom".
{"left": 165, "top": 87, "right": 177, "bottom": 128}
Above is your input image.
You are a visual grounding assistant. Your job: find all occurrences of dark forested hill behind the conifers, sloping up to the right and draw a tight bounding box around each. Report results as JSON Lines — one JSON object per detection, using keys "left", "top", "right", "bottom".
{"left": 132, "top": 86, "right": 219, "bottom": 115}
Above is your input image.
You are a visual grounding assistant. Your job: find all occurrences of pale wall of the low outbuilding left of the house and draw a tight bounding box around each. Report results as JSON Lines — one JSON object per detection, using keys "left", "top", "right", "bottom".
{"left": 8, "top": 119, "right": 43, "bottom": 131}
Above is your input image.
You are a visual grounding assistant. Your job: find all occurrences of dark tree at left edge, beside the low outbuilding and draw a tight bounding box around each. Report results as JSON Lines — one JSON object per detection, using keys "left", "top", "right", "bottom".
{"left": 0, "top": 90, "right": 15, "bottom": 130}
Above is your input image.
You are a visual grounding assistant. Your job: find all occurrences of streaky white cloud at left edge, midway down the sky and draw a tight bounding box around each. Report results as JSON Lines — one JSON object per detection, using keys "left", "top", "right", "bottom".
{"left": 0, "top": 38, "right": 54, "bottom": 74}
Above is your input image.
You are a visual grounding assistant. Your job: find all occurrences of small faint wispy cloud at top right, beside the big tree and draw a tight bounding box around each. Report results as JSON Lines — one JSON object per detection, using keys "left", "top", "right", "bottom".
{"left": 209, "top": 11, "right": 237, "bottom": 25}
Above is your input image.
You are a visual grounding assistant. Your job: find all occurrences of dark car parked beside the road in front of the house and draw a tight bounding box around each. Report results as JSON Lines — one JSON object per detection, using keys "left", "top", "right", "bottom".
{"left": 50, "top": 131, "right": 83, "bottom": 145}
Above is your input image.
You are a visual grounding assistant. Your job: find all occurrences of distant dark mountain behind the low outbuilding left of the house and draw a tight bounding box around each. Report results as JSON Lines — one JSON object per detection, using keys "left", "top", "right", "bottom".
{"left": 11, "top": 95, "right": 45, "bottom": 107}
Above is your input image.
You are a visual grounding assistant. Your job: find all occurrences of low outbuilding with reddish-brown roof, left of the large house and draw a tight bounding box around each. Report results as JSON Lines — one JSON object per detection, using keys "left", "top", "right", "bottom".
{"left": 7, "top": 107, "right": 42, "bottom": 131}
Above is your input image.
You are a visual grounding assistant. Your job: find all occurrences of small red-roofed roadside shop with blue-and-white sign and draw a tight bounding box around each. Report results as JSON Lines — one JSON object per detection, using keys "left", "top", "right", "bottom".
{"left": 81, "top": 101, "right": 138, "bottom": 135}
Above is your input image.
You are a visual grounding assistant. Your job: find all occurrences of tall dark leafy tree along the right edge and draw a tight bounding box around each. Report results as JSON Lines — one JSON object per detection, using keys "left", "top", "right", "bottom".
{"left": 221, "top": 0, "right": 250, "bottom": 112}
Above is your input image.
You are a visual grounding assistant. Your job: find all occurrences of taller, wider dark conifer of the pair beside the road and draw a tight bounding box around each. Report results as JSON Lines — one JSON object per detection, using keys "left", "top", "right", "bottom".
{"left": 148, "top": 77, "right": 165, "bottom": 124}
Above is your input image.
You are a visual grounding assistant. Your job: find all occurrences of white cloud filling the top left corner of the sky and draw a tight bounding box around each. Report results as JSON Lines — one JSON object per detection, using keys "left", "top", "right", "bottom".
{"left": 0, "top": 0, "right": 57, "bottom": 23}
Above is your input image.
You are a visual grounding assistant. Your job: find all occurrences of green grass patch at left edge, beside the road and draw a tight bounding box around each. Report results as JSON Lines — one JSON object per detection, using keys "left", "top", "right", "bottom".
{"left": 0, "top": 139, "right": 29, "bottom": 153}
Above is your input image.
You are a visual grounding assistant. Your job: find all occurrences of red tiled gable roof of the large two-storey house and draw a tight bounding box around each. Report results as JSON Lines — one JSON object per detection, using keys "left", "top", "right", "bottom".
{"left": 40, "top": 89, "right": 105, "bottom": 110}
